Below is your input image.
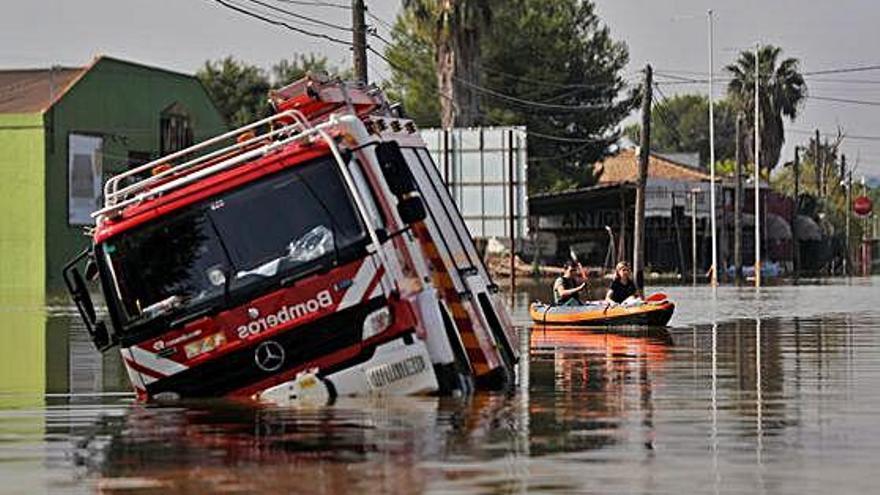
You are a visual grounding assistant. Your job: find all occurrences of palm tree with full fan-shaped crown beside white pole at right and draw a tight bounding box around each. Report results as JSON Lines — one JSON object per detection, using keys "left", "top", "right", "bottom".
{"left": 725, "top": 45, "right": 807, "bottom": 171}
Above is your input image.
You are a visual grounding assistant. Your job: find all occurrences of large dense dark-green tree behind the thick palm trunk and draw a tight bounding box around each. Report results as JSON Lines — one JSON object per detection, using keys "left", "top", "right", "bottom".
{"left": 386, "top": 0, "right": 638, "bottom": 191}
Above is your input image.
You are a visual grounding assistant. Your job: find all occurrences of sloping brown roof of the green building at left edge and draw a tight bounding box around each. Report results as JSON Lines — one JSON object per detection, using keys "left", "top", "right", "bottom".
{"left": 0, "top": 67, "right": 88, "bottom": 113}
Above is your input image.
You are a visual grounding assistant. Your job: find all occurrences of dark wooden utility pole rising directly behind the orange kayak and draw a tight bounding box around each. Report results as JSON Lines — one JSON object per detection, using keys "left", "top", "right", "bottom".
{"left": 633, "top": 64, "right": 653, "bottom": 293}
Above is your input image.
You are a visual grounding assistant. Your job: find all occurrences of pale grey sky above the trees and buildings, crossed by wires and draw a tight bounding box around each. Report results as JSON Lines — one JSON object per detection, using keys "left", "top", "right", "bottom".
{"left": 0, "top": 0, "right": 880, "bottom": 177}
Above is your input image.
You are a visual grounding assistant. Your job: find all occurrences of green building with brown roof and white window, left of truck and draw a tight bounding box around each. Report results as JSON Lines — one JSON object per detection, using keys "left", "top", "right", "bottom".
{"left": 0, "top": 56, "right": 226, "bottom": 306}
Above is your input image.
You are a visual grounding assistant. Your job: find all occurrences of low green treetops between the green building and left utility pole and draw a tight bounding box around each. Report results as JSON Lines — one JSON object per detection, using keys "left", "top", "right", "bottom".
{"left": 196, "top": 54, "right": 350, "bottom": 127}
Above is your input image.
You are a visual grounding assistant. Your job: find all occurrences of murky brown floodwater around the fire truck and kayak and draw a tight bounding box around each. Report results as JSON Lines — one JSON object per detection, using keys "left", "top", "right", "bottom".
{"left": 0, "top": 277, "right": 880, "bottom": 494}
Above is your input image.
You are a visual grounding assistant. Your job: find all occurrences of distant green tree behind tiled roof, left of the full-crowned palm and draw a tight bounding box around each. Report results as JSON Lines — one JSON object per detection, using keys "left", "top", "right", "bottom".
{"left": 626, "top": 94, "right": 736, "bottom": 167}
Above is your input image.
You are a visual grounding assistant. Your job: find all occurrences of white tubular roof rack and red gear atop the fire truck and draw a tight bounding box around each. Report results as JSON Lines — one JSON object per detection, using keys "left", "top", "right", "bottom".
{"left": 92, "top": 74, "right": 389, "bottom": 223}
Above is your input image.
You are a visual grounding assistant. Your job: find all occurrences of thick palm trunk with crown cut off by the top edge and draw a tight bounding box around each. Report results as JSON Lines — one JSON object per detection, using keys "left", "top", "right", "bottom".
{"left": 403, "top": 0, "right": 491, "bottom": 128}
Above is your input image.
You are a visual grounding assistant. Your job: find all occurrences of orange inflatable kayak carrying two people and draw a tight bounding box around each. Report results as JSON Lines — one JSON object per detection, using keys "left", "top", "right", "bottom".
{"left": 529, "top": 299, "right": 675, "bottom": 326}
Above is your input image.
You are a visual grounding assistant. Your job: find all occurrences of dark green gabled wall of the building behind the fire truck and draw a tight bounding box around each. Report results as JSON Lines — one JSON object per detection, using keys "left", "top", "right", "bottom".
{"left": 45, "top": 58, "right": 226, "bottom": 295}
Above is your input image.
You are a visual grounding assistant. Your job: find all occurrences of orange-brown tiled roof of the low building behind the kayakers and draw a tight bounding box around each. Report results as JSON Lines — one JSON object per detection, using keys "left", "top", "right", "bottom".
{"left": 596, "top": 149, "right": 709, "bottom": 184}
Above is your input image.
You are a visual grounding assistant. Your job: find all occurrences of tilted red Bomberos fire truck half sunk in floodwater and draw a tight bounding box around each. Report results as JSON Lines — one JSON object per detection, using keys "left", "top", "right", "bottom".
{"left": 64, "top": 76, "right": 517, "bottom": 404}
